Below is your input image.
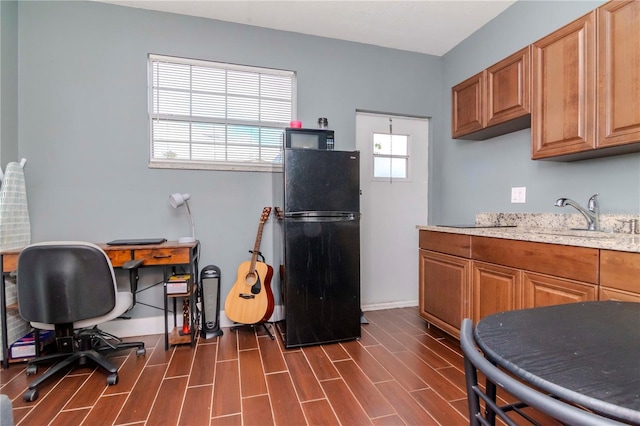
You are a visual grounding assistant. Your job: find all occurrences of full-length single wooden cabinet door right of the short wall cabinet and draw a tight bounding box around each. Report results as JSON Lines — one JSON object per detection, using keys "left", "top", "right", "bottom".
{"left": 531, "top": 11, "right": 596, "bottom": 159}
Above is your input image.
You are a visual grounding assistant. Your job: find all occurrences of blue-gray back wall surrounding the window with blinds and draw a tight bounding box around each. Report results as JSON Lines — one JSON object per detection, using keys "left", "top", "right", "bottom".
{"left": 19, "top": 2, "right": 443, "bottom": 315}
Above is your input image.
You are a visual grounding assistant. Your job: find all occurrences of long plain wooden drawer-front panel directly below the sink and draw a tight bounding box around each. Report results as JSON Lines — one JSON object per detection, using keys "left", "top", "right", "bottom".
{"left": 471, "top": 236, "right": 599, "bottom": 284}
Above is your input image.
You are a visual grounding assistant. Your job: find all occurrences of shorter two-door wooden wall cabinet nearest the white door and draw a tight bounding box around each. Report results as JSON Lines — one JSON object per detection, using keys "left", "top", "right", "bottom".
{"left": 451, "top": 47, "right": 531, "bottom": 140}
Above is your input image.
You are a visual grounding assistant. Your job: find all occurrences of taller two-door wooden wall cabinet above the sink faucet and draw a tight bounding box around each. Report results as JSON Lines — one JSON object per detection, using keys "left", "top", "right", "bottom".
{"left": 531, "top": 1, "right": 640, "bottom": 161}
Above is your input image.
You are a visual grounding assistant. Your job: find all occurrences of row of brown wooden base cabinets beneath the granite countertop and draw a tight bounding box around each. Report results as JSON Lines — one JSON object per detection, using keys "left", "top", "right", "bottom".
{"left": 419, "top": 230, "right": 620, "bottom": 337}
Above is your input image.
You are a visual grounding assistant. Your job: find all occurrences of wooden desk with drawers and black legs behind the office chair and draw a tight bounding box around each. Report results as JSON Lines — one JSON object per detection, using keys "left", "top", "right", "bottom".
{"left": 0, "top": 241, "right": 200, "bottom": 368}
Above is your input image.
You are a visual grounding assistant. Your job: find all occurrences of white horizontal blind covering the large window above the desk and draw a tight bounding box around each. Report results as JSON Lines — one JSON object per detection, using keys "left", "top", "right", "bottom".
{"left": 149, "top": 55, "right": 296, "bottom": 170}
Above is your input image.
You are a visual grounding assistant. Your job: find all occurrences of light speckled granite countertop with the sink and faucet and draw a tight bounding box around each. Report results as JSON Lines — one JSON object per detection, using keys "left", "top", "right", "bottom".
{"left": 417, "top": 225, "right": 640, "bottom": 253}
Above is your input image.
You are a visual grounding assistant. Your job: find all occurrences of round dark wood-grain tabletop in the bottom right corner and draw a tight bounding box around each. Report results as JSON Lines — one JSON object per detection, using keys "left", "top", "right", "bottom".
{"left": 474, "top": 301, "right": 640, "bottom": 424}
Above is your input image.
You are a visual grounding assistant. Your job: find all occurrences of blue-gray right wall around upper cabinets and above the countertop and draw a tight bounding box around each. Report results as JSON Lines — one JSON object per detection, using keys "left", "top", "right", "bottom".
{"left": 438, "top": 0, "right": 640, "bottom": 223}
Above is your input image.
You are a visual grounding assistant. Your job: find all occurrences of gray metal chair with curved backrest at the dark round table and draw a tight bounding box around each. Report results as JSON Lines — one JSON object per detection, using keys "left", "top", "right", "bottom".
{"left": 460, "top": 318, "right": 623, "bottom": 426}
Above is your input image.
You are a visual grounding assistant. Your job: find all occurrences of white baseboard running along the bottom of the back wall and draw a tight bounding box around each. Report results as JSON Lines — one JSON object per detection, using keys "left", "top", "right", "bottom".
{"left": 100, "top": 300, "right": 418, "bottom": 337}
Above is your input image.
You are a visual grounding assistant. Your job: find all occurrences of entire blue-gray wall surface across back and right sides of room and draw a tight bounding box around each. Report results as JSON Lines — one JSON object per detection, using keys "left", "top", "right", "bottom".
{"left": 2, "top": 0, "right": 640, "bottom": 316}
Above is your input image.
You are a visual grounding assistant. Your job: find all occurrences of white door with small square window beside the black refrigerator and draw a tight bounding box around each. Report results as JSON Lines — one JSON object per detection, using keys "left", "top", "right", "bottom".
{"left": 356, "top": 112, "right": 429, "bottom": 310}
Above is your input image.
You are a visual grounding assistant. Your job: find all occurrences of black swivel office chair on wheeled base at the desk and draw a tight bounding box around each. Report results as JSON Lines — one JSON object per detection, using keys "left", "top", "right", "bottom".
{"left": 17, "top": 241, "right": 146, "bottom": 402}
